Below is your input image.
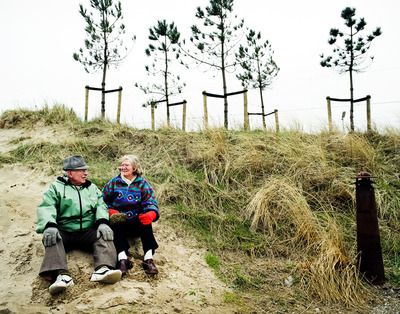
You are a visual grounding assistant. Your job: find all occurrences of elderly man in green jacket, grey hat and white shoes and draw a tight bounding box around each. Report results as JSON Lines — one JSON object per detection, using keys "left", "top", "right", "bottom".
{"left": 36, "top": 155, "right": 122, "bottom": 294}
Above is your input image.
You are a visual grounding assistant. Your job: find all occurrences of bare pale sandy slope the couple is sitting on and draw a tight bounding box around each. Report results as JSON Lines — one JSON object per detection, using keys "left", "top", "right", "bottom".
{"left": 0, "top": 129, "right": 236, "bottom": 313}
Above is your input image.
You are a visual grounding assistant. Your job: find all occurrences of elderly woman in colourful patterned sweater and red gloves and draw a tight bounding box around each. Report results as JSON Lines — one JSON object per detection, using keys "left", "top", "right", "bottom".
{"left": 102, "top": 155, "right": 160, "bottom": 274}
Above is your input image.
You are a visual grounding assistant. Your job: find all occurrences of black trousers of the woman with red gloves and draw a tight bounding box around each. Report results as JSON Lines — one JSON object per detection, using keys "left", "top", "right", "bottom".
{"left": 112, "top": 220, "right": 158, "bottom": 254}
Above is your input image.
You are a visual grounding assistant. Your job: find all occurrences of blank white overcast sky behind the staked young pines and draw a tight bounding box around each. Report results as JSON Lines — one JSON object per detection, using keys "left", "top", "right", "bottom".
{"left": 0, "top": 0, "right": 400, "bottom": 131}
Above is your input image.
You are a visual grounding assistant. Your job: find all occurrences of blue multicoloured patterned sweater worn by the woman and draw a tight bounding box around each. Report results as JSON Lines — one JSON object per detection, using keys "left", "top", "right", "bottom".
{"left": 102, "top": 174, "right": 160, "bottom": 221}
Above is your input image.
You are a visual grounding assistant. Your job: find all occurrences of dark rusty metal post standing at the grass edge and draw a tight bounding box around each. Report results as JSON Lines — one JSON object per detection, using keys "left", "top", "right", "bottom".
{"left": 355, "top": 172, "right": 386, "bottom": 285}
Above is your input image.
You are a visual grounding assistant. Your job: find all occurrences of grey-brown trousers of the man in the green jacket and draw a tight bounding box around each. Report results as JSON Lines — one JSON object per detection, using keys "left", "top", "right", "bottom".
{"left": 39, "top": 229, "right": 117, "bottom": 280}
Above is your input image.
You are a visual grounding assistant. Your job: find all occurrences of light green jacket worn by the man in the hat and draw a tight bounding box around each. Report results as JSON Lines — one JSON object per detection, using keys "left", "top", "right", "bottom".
{"left": 36, "top": 177, "right": 109, "bottom": 233}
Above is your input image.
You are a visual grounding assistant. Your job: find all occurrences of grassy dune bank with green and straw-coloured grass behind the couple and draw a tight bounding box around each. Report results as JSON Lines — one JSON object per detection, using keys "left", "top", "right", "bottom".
{"left": 0, "top": 105, "right": 400, "bottom": 311}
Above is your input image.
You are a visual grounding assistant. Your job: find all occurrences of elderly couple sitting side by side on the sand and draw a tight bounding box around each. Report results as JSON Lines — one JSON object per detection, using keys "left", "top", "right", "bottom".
{"left": 36, "top": 155, "right": 159, "bottom": 294}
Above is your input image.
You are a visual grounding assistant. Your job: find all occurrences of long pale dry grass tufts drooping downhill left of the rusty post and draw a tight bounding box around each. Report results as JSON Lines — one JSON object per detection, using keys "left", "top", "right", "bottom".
{"left": 246, "top": 177, "right": 372, "bottom": 309}
